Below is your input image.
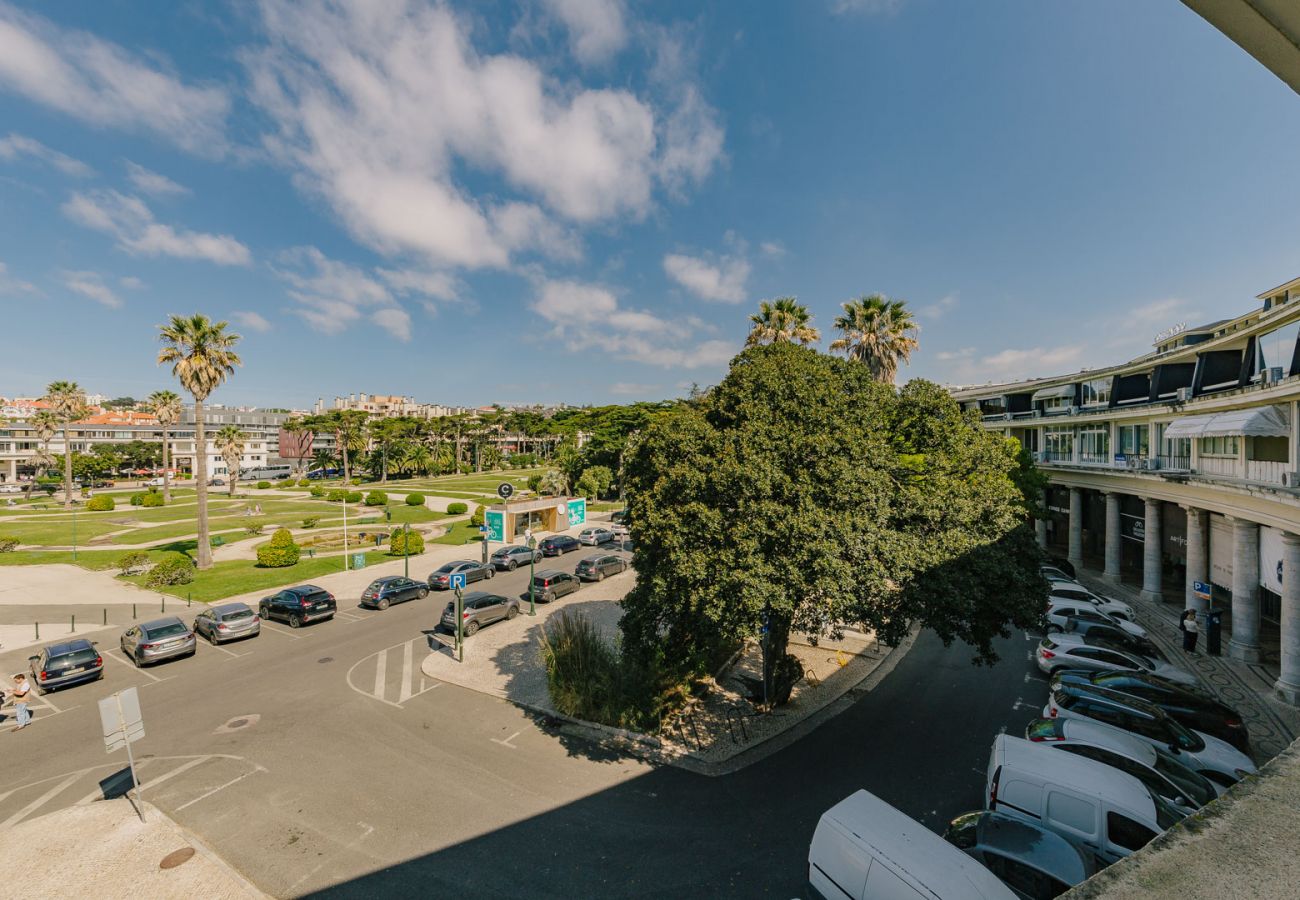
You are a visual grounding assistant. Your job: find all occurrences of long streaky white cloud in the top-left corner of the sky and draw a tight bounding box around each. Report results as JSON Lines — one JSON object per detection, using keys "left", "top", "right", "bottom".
{"left": 0, "top": 0, "right": 230, "bottom": 156}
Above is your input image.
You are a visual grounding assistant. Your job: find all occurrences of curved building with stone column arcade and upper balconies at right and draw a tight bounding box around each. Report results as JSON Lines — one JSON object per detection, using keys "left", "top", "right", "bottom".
{"left": 953, "top": 271, "right": 1300, "bottom": 705}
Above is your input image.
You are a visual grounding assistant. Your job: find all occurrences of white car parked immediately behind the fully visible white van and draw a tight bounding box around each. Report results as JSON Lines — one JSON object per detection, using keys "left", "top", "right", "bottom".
{"left": 1024, "top": 718, "right": 1219, "bottom": 815}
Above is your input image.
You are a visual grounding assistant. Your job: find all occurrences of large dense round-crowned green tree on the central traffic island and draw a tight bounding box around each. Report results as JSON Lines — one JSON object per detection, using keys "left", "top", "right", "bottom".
{"left": 621, "top": 343, "right": 1045, "bottom": 702}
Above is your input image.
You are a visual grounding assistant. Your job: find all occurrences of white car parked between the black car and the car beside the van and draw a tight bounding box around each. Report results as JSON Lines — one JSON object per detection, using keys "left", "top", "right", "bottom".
{"left": 1043, "top": 684, "right": 1256, "bottom": 787}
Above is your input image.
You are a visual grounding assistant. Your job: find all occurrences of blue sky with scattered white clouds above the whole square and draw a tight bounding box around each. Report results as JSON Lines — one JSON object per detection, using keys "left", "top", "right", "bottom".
{"left": 0, "top": 0, "right": 1300, "bottom": 406}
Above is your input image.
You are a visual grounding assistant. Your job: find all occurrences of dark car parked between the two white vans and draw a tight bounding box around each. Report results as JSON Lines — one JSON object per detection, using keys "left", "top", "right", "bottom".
{"left": 944, "top": 810, "right": 1097, "bottom": 900}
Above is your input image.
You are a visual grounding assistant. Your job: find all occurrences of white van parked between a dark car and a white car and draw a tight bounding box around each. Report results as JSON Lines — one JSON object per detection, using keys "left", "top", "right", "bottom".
{"left": 987, "top": 735, "right": 1183, "bottom": 865}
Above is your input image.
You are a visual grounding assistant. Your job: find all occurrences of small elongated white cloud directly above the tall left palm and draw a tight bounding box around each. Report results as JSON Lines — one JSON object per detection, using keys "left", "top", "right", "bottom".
{"left": 62, "top": 191, "right": 252, "bottom": 265}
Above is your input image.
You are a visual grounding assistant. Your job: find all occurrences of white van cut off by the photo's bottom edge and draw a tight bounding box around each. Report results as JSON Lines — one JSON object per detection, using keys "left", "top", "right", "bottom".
{"left": 809, "top": 795, "right": 1008, "bottom": 900}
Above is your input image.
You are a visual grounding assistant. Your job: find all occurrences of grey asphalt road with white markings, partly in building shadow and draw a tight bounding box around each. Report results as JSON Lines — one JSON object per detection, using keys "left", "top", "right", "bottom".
{"left": 0, "top": 553, "right": 1047, "bottom": 897}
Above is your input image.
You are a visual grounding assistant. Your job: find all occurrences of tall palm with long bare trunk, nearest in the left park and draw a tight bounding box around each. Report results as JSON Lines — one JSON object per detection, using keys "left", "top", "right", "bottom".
{"left": 159, "top": 312, "right": 243, "bottom": 568}
